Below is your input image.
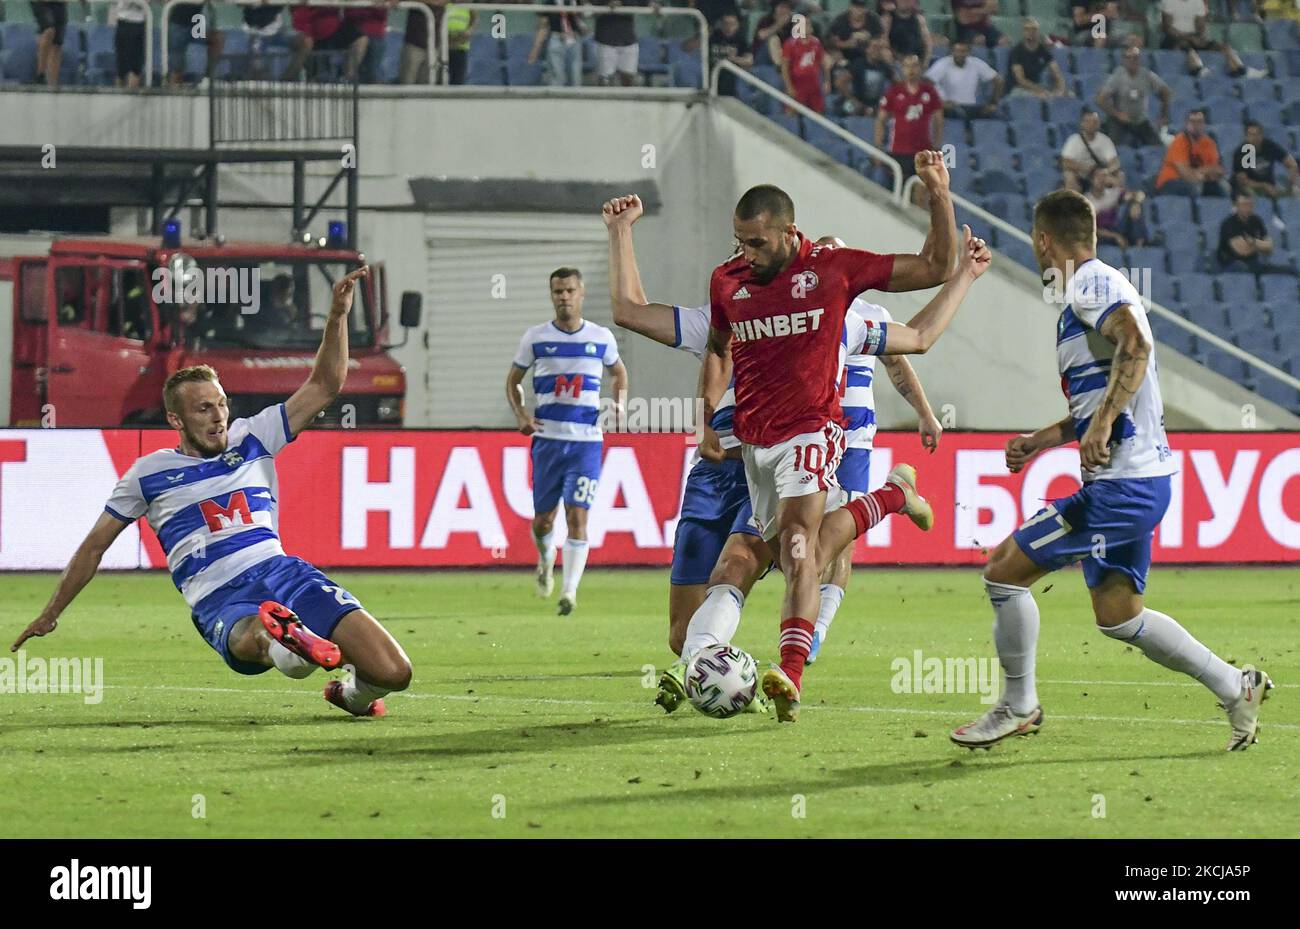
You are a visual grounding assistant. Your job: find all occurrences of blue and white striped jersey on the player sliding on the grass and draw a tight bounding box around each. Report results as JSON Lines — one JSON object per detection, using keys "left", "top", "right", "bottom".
{"left": 104, "top": 403, "right": 294, "bottom": 607}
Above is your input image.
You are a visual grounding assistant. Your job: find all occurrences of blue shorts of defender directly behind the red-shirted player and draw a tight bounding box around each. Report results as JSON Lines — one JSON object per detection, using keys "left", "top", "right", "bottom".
{"left": 670, "top": 459, "right": 758, "bottom": 585}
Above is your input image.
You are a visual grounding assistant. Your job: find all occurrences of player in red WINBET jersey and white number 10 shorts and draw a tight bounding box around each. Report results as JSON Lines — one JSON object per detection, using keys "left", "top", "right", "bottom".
{"left": 709, "top": 152, "right": 957, "bottom": 721}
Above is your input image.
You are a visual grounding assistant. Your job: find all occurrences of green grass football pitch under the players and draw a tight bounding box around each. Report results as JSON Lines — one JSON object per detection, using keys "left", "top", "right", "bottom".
{"left": 0, "top": 566, "right": 1300, "bottom": 837}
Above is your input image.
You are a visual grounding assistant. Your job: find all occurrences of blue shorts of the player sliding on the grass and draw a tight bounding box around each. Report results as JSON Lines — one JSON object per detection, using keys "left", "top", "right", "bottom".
{"left": 192, "top": 555, "right": 361, "bottom": 674}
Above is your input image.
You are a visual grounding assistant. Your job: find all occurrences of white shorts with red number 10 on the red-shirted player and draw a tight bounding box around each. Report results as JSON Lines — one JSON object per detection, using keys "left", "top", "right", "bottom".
{"left": 741, "top": 422, "right": 849, "bottom": 541}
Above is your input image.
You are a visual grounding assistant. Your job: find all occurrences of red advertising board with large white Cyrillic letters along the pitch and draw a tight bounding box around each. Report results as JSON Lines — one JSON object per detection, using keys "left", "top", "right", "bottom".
{"left": 0, "top": 429, "right": 1300, "bottom": 570}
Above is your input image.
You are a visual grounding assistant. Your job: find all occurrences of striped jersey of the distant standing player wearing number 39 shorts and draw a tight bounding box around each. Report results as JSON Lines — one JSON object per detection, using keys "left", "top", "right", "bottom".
{"left": 515, "top": 320, "right": 619, "bottom": 442}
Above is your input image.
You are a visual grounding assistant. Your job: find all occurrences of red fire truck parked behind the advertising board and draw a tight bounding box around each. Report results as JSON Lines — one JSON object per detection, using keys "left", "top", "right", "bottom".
{"left": 0, "top": 230, "right": 421, "bottom": 427}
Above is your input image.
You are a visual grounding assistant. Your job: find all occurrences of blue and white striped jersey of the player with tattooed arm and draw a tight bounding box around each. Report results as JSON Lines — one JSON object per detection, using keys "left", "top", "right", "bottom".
{"left": 1057, "top": 259, "right": 1178, "bottom": 482}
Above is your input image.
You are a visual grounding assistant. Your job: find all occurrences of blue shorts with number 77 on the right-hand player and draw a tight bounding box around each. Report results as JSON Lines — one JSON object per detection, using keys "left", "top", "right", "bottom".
{"left": 1014, "top": 476, "right": 1170, "bottom": 594}
